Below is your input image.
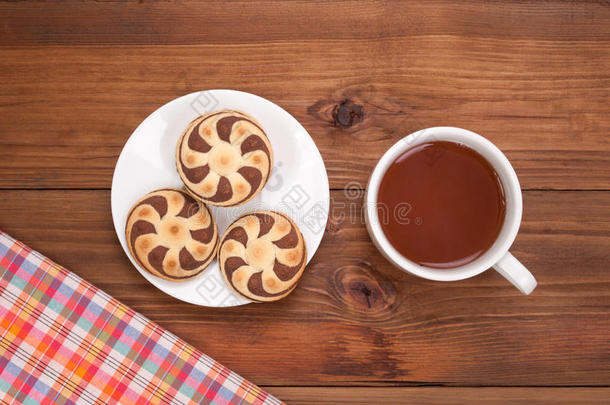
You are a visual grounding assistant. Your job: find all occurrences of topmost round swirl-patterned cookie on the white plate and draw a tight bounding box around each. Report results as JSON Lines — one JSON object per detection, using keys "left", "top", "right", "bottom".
{"left": 176, "top": 110, "right": 273, "bottom": 207}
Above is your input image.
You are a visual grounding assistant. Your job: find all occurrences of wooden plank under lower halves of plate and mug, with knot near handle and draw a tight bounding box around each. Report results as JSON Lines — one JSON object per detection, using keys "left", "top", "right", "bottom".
{"left": 0, "top": 190, "right": 610, "bottom": 386}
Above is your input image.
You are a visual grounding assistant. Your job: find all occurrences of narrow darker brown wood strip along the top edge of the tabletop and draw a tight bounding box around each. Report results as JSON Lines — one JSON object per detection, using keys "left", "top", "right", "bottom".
{"left": 0, "top": 0, "right": 610, "bottom": 46}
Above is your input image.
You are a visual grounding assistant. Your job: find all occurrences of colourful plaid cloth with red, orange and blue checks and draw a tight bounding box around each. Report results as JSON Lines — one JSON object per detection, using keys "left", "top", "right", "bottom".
{"left": 0, "top": 231, "right": 280, "bottom": 404}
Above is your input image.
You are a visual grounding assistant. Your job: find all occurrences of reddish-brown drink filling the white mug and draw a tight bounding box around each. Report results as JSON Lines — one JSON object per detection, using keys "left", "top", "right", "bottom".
{"left": 377, "top": 141, "right": 506, "bottom": 269}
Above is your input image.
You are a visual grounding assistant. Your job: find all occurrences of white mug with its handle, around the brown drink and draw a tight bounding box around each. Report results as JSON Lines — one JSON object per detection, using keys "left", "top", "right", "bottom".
{"left": 365, "top": 127, "right": 537, "bottom": 294}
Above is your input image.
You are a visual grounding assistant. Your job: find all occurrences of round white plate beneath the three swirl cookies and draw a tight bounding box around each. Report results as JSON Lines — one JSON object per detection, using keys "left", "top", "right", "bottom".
{"left": 111, "top": 90, "right": 329, "bottom": 307}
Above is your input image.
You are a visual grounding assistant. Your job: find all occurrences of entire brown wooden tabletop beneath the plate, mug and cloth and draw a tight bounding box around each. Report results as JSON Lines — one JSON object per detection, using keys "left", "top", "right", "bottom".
{"left": 0, "top": 0, "right": 610, "bottom": 404}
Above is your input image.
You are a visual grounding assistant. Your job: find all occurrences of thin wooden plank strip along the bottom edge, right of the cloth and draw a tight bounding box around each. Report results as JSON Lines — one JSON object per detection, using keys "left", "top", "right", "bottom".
{"left": 266, "top": 387, "right": 610, "bottom": 405}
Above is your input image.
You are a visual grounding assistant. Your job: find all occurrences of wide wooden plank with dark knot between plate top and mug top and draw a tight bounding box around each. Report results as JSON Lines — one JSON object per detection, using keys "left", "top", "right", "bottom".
{"left": 0, "top": 39, "right": 610, "bottom": 190}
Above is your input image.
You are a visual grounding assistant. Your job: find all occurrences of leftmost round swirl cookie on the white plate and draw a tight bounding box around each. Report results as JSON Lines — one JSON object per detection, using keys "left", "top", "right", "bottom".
{"left": 125, "top": 188, "right": 219, "bottom": 281}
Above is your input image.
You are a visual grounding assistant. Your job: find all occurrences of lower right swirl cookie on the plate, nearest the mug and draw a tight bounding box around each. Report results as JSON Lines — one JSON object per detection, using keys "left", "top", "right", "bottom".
{"left": 218, "top": 211, "right": 307, "bottom": 302}
